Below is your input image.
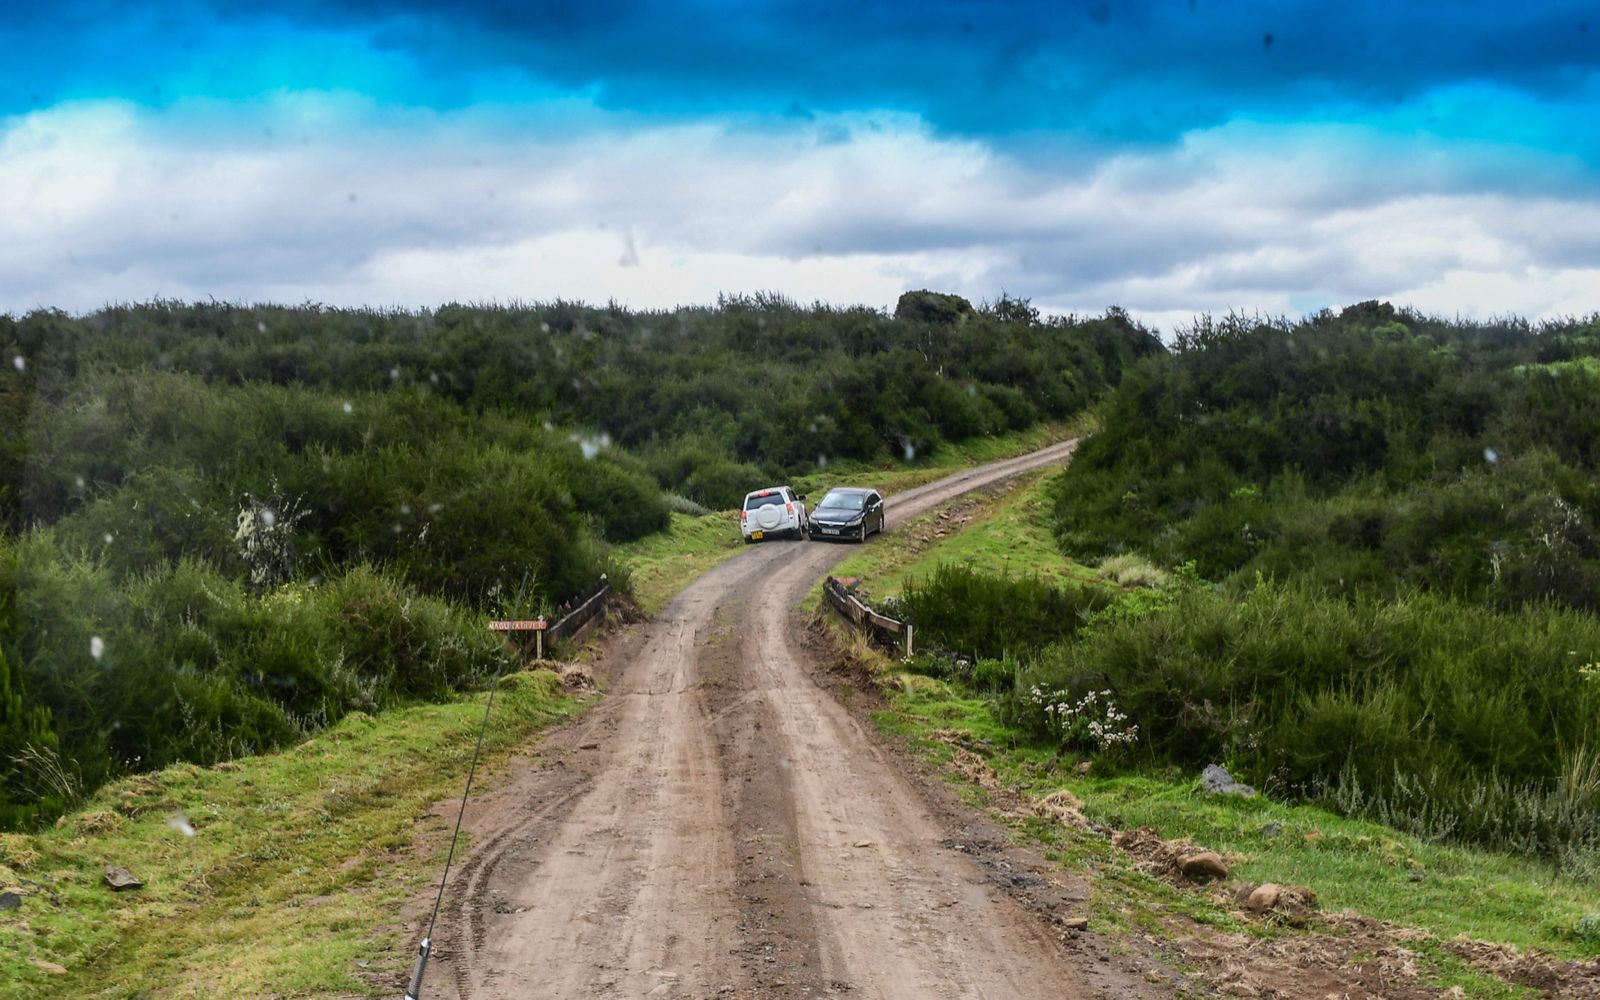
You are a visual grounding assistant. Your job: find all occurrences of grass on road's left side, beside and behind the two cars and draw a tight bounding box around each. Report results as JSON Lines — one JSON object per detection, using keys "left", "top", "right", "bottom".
{"left": 616, "top": 418, "right": 1086, "bottom": 614}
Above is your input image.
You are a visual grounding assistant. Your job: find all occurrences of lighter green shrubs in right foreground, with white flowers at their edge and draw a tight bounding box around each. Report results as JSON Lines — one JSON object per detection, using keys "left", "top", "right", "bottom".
{"left": 1016, "top": 582, "right": 1600, "bottom": 853}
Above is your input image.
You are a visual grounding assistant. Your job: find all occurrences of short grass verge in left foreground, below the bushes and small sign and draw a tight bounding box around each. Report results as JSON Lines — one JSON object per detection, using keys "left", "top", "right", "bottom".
{"left": 0, "top": 672, "right": 581, "bottom": 1000}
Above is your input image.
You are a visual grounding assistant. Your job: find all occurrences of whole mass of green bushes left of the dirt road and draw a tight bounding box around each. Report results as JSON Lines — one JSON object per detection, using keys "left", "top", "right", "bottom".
{"left": 0, "top": 296, "right": 1160, "bottom": 829}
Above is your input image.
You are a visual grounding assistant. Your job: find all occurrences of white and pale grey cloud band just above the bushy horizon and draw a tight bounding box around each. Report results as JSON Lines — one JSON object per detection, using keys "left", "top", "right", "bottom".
{"left": 0, "top": 94, "right": 1600, "bottom": 328}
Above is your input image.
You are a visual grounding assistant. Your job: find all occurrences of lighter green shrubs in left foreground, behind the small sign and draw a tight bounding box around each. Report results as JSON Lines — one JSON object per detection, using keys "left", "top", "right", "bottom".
{"left": 0, "top": 533, "right": 507, "bottom": 805}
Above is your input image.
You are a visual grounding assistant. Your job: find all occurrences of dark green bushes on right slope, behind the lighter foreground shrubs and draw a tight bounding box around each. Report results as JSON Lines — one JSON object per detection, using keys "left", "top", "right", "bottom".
{"left": 1056, "top": 304, "right": 1600, "bottom": 610}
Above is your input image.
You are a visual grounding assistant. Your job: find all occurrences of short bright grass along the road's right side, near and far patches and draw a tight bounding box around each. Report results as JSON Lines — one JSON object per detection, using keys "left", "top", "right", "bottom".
{"left": 840, "top": 477, "right": 1600, "bottom": 997}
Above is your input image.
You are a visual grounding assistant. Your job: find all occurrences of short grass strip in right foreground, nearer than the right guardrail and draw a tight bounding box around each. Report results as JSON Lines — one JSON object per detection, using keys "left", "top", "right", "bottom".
{"left": 877, "top": 675, "right": 1600, "bottom": 958}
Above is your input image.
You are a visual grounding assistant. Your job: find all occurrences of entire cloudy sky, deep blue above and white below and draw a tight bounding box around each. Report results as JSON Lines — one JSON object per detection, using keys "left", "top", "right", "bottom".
{"left": 0, "top": 0, "right": 1600, "bottom": 330}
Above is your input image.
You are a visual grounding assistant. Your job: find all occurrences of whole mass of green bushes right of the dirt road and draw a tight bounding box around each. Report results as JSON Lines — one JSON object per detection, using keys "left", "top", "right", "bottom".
{"left": 1021, "top": 304, "right": 1600, "bottom": 851}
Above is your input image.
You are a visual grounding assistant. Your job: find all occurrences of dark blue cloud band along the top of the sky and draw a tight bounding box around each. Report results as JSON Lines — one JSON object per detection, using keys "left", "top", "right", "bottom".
{"left": 0, "top": 0, "right": 1600, "bottom": 155}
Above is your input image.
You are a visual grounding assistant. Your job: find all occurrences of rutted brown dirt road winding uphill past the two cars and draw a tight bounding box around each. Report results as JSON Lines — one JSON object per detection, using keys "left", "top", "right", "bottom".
{"left": 426, "top": 443, "right": 1158, "bottom": 1000}
